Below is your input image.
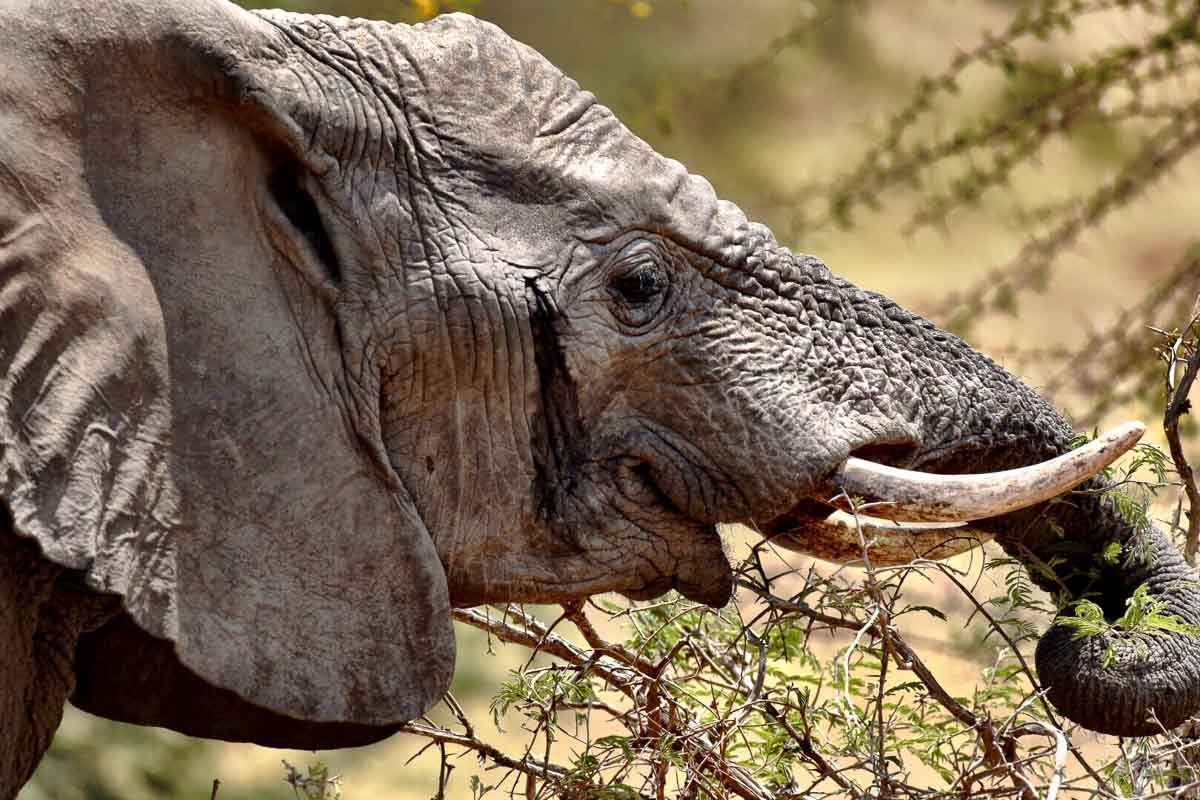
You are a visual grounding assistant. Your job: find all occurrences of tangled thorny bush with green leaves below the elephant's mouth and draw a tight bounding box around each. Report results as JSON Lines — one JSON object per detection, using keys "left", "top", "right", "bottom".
{"left": 391, "top": 506, "right": 1195, "bottom": 800}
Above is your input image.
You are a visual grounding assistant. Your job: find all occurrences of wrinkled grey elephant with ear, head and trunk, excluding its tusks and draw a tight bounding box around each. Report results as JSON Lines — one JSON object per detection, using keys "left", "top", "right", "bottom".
{"left": 0, "top": 0, "right": 1200, "bottom": 798}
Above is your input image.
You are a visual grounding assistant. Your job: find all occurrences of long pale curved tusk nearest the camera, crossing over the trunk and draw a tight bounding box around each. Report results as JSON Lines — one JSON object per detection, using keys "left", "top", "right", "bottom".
{"left": 828, "top": 422, "right": 1146, "bottom": 522}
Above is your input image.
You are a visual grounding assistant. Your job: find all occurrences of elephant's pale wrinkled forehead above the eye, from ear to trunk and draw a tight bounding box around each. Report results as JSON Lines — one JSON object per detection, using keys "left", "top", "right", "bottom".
{"left": 263, "top": 12, "right": 746, "bottom": 263}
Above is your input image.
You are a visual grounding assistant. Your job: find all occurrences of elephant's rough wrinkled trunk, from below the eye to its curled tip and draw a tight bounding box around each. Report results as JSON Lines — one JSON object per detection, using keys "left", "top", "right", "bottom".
{"left": 754, "top": 252, "right": 1200, "bottom": 735}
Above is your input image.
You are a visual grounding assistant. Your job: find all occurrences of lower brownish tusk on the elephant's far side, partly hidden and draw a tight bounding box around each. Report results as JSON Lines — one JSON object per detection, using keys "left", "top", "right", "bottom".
{"left": 770, "top": 511, "right": 991, "bottom": 566}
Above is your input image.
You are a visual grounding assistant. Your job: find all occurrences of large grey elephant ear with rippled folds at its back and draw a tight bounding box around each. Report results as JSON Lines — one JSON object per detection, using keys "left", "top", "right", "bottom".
{"left": 0, "top": 0, "right": 454, "bottom": 747}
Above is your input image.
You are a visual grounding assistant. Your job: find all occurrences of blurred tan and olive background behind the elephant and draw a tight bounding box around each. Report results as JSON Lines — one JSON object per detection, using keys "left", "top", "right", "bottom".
{"left": 20, "top": 0, "right": 1200, "bottom": 800}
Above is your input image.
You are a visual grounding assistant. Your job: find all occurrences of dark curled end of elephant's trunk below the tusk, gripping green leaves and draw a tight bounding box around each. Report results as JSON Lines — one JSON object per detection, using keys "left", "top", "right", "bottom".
{"left": 997, "top": 479, "right": 1200, "bottom": 736}
